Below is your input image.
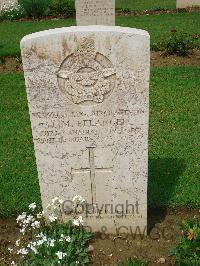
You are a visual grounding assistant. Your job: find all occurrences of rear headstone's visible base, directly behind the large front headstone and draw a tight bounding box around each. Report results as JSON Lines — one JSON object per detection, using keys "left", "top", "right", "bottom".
{"left": 76, "top": 0, "right": 115, "bottom": 26}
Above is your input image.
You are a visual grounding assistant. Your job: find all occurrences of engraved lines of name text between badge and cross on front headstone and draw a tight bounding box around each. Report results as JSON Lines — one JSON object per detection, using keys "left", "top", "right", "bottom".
{"left": 32, "top": 109, "right": 144, "bottom": 144}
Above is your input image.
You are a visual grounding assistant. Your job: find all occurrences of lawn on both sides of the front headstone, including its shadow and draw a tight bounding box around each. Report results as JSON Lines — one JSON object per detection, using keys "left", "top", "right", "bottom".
{"left": 0, "top": 67, "right": 200, "bottom": 216}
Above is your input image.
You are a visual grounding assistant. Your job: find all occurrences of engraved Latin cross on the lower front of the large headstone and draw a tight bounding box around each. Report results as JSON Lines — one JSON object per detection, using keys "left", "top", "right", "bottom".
{"left": 71, "top": 147, "right": 113, "bottom": 204}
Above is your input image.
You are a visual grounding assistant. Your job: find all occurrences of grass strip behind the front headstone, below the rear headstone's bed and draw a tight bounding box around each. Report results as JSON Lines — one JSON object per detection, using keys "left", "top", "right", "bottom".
{"left": 0, "top": 13, "right": 200, "bottom": 58}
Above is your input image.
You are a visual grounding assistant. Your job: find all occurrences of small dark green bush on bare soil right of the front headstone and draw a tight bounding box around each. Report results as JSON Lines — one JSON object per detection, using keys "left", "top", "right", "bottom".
{"left": 152, "top": 29, "right": 196, "bottom": 56}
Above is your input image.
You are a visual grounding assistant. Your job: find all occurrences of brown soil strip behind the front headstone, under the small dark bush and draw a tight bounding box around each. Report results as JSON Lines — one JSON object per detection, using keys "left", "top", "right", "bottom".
{"left": 0, "top": 50, "right": 200, "bottom": 73}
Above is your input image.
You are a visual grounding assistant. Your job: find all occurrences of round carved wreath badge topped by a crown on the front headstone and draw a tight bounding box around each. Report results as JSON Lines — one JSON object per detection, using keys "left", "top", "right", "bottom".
{"left": 57, "top": 38, "right": 116, "bottom": 105}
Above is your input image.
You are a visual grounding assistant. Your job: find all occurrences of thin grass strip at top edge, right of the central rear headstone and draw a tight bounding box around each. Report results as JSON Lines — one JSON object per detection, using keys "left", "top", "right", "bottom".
{"left": 116, "top": 0, "right": 176, "bottom": 10}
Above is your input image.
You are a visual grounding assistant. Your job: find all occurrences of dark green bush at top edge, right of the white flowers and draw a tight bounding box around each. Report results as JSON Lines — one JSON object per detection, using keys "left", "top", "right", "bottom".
{"left": 18, "top": 0, "right": 52, "bottom": 18}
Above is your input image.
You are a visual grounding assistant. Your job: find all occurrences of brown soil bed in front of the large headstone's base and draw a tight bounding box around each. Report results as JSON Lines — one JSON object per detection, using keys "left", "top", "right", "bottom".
{"left": 0, "top": 208, "right": 200, "bottom": 266}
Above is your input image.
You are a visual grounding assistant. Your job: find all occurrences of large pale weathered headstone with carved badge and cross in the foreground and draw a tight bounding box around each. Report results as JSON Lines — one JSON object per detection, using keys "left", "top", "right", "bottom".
{"left": 21, "top": 26, "right": 150, "bottom": 233}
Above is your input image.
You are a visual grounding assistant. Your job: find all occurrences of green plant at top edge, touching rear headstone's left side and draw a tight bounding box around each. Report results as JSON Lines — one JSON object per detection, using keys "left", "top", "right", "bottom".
{"left": 48, "top": 0, "right": 75, "bottom": 17}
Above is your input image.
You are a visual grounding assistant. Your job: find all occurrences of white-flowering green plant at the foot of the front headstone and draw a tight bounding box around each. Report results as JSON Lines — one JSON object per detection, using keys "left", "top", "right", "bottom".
{"left": 9, "top": 196, "right": 91, "bottom": 266}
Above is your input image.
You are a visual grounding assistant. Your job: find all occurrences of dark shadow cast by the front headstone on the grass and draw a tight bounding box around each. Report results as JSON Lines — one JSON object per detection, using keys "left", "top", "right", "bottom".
{"left": 148, "top": 158, "right": 186, "bottom": 229}
